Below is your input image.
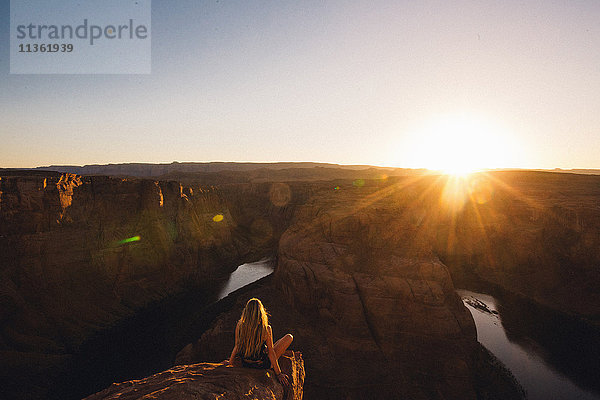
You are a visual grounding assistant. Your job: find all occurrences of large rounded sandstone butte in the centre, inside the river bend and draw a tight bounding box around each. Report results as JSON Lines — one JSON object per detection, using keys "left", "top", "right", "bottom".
{"left": 177, "top": 177, "right": 521, "bottom": 399}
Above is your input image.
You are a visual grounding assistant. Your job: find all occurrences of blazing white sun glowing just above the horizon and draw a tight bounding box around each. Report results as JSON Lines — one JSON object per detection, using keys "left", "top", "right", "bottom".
{"left": 401, "top": 115, "right": 514, "bottom": 176}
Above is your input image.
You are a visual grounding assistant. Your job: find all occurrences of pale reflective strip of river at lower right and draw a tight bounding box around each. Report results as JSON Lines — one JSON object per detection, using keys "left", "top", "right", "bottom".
{"left": 457, "top": 290, "right": 600, "bottom": 400}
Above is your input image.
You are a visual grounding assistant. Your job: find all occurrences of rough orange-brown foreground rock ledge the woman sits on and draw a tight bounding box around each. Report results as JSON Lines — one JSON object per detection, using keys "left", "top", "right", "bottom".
{"left": 86, "top": 352, "right": 304, "bottom": 400}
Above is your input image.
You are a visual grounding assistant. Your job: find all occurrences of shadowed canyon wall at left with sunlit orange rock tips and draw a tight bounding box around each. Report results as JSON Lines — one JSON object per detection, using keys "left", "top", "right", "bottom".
{"left": 0, "top": 173, "right": 274, "bottom": 398}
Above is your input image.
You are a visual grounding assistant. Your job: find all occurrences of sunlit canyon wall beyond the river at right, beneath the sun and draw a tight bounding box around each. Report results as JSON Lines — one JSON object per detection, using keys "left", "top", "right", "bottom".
{"left": 424, "top": 172, "right": 600, "bottom": 327}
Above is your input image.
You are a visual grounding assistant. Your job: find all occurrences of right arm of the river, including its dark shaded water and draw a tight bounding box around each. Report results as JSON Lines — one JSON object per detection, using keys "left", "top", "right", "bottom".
{"left": 457, "top": 290, "right": 600, "bottom": 400}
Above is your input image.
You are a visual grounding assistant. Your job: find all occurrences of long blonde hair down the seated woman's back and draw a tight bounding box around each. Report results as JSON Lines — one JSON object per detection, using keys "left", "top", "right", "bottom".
{"left": 235, "top": 298, "right": 269, "bottom": 359}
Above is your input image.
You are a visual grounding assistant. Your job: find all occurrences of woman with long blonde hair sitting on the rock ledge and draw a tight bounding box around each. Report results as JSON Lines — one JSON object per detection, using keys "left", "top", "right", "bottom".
{"left": 228, "top": 298, "right": 294, "bottom": 386}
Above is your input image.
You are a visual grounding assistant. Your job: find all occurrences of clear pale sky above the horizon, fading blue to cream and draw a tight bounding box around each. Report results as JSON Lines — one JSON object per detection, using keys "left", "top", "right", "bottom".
{"left": 0, "top": 0, "right": 600, "bottom": 168}
